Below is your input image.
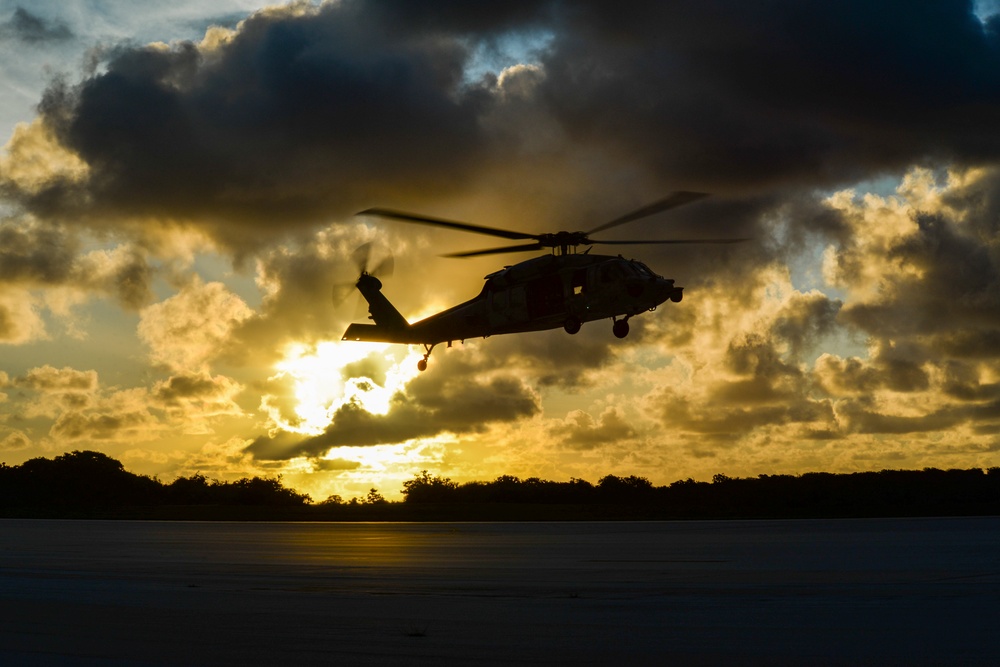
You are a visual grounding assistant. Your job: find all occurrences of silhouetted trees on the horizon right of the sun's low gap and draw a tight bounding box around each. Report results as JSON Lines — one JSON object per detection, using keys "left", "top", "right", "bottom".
{"left": 403, "top": 468, "right": 1000, "bottom": 519}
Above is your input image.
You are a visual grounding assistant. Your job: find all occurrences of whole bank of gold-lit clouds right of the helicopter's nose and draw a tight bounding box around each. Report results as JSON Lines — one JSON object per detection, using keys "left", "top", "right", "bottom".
{"left": 632, "top": 169, "right": 1000, "bottom": 455}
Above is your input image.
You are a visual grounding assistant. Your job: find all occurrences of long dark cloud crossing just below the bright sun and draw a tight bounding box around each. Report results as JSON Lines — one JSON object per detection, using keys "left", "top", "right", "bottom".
{"left": 247, "top": 375, "right": 539, "bottom": 460}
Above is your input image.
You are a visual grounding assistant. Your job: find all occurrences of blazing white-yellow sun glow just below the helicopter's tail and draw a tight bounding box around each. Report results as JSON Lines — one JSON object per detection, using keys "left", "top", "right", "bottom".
{"left": 272, "top": 342, "right": 422, "bottom": 435}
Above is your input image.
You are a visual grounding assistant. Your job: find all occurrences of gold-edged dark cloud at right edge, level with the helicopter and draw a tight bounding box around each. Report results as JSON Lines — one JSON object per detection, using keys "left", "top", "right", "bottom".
{"left": 825, "top": 170, "right": 1000, "bottom": 362}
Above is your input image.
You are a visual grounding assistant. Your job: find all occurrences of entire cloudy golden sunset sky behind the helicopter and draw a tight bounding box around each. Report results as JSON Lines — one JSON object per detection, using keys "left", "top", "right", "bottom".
{"left": 0, "top": 0, "right": 1000, "bottom": 500}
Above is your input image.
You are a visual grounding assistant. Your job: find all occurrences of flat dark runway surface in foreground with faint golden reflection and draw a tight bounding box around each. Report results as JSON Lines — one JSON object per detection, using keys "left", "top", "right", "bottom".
{"left": 0, "top": 518, "right": 1000, "bottom": 665}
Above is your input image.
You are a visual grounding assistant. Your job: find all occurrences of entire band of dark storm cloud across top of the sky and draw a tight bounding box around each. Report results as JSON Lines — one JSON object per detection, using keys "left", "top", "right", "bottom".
{"left": 8, "top": 0, "right": 1000, "bottom": 246}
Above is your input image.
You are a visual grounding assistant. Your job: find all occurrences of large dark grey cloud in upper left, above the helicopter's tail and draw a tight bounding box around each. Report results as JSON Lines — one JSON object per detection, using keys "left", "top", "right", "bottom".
{"left": 21, "top": 3, "right": 490, "bottom": 244}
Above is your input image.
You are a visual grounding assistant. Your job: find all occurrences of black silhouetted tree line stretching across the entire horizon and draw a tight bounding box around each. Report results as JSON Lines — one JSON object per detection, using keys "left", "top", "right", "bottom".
{"left": 0, "top": 451, "right": 1000, "bottom": 520}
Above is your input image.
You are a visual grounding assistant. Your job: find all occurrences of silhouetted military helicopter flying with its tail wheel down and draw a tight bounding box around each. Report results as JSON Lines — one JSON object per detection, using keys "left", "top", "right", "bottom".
{"left": 341, "top": 191, "right": 747, "bottom": 371}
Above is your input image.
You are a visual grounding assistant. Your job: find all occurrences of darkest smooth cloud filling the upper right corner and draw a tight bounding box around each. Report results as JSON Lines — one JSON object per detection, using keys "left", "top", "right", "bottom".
{"left": 544, "top": 0, "right": 1000, "bottom": 188}
